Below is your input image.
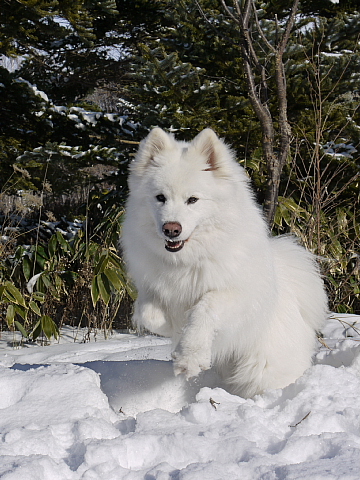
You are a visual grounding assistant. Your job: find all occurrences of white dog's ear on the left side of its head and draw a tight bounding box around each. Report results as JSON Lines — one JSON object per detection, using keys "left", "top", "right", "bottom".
{"left": 131, "top": 127, "right": 174, "bottom": 175}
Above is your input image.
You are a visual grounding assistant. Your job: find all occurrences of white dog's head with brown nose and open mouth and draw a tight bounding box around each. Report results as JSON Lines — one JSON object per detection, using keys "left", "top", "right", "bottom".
{"left": 129, "top": 128, "right": 243, "bottom": 253}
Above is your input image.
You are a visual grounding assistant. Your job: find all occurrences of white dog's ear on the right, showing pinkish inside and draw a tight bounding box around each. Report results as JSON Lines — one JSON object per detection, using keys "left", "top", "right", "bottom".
{"left": 191, "top": 128, "right": 232, "bottom": 177}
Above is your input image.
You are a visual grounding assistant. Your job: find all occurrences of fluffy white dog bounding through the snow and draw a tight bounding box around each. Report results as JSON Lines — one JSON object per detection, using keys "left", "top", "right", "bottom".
{"left": 122, "top": 128, "right": 327, "bottom": 397}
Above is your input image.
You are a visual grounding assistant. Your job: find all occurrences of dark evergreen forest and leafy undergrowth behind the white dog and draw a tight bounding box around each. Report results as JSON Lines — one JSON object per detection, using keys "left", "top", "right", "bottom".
{"left": 0, "top": 0, "right": 360, "bottom": 341}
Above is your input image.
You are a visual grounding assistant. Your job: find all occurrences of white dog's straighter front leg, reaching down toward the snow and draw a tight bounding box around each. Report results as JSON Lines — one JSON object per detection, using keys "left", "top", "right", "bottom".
{"left": 173, "top": 292, "right": 224, "bottom": 379}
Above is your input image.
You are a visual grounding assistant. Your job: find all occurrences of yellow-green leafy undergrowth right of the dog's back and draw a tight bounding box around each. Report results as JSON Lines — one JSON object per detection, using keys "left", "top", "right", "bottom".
{"left": 275, "top": 197, "right": 360, "bottom": 313}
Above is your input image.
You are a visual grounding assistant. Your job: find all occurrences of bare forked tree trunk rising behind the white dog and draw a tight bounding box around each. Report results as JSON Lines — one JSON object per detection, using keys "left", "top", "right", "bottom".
{"left": 221, "top": 0, "right": 299, "bottom": 228}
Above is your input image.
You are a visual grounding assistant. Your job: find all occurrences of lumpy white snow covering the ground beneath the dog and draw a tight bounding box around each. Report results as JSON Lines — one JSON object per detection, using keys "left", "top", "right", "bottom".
{"left": 0, "top": 316, "right": 360, "bottom": 480}
